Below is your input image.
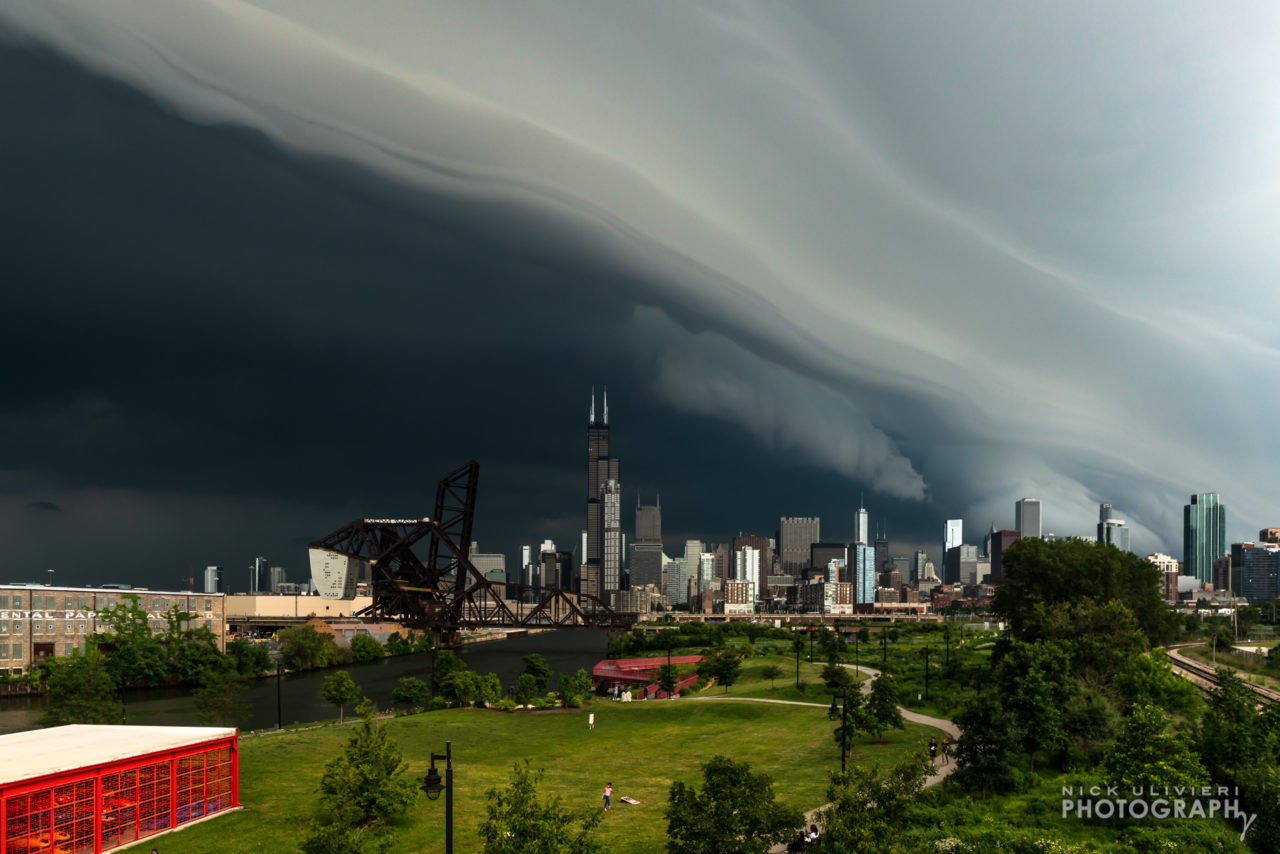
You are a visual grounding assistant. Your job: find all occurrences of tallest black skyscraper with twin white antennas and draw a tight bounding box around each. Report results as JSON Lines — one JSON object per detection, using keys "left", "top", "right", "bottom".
{"left": 581, "top": 391, "right": 622, "bottom": 600}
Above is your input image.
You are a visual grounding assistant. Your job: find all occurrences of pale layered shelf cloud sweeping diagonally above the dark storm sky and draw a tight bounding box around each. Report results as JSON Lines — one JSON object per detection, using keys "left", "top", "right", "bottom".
{"left": 0, "top": 0, "right": 1280, "bottom": 578}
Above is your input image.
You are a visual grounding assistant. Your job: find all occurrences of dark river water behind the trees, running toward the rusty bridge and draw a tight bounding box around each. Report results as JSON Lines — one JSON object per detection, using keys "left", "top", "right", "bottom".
{"left": 0, "top": 629, "right": 608, "bottom": 734}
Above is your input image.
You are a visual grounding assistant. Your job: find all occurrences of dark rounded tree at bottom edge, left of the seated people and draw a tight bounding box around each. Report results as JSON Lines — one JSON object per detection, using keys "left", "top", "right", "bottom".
{"left": 667, "top": 757, "right": 804, "bottom": 854}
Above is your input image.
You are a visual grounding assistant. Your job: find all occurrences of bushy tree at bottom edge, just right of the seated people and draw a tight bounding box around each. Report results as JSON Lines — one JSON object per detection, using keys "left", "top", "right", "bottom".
{"left": 818, "top": 757, "right": 931, "bottom": 854}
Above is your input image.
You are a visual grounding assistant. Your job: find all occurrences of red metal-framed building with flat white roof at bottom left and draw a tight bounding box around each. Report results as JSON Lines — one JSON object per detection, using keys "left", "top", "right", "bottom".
{"left": 0, "top": 725, "right": 239, "bottom": 854}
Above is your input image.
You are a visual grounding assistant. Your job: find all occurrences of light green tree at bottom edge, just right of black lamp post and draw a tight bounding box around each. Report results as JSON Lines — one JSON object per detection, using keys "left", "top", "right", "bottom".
{"left": 480, "top": 759, "right": 604, "bottom": 854}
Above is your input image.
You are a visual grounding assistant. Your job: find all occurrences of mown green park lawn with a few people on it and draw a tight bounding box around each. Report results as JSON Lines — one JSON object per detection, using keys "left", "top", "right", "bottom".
{"left": 120, "top": 696, "right": 934, "bottom": 854}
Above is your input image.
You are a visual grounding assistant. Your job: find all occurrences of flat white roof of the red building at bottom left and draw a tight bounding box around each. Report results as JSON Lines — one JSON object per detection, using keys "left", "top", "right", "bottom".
{"left": 0, "top": 723, "right": 236, "bottom": 785}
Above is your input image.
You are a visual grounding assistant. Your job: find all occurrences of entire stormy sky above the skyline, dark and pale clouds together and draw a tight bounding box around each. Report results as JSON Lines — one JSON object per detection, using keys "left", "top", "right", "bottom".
{"left": 0, "top": 0, "right": 1280, "bottom": 589}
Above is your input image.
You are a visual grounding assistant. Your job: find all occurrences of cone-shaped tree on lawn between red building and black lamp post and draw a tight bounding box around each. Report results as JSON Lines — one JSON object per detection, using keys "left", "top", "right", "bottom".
{"left": 302, "top": 700, "right": 417, "bottom": 854}
